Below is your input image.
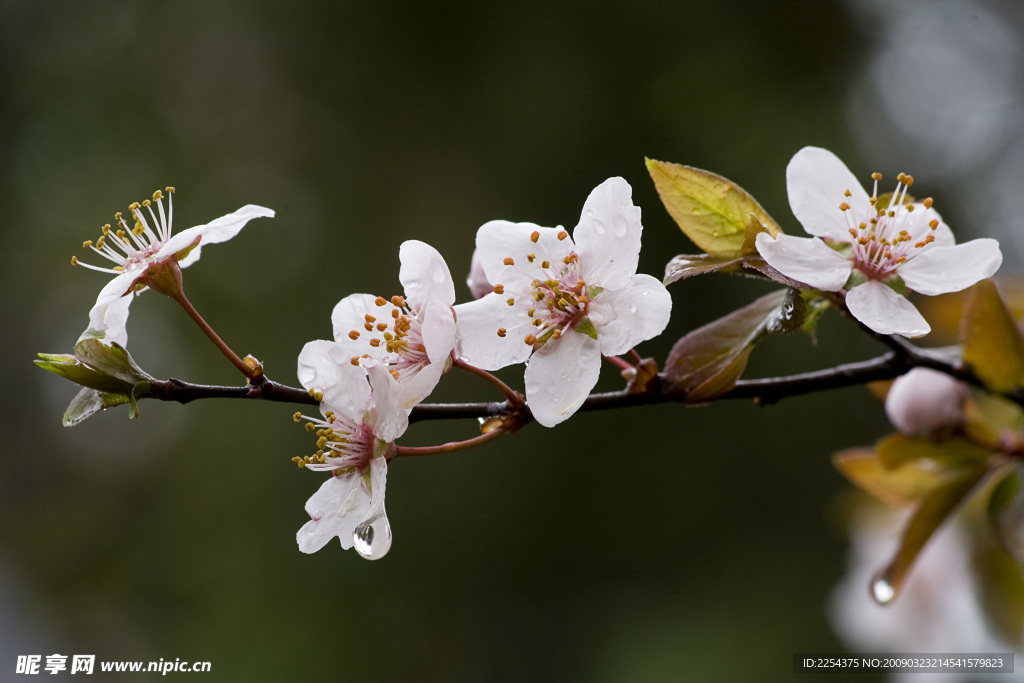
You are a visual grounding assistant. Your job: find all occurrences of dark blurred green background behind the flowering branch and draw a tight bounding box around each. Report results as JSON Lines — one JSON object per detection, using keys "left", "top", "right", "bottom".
{"left": 0, "top": 0, "right": 1021, "bottom": 682}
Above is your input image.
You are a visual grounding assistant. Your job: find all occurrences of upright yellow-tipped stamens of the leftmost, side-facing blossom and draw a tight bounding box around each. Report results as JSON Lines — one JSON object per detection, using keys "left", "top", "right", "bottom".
{"left": 71, "top": 187, "right": 174, "bottom": 273}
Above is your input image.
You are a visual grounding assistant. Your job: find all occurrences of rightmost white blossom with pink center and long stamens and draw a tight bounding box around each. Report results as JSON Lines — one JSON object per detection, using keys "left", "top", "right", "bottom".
{"left": 757, "top": 147, "right": 1002, "bottom": 337}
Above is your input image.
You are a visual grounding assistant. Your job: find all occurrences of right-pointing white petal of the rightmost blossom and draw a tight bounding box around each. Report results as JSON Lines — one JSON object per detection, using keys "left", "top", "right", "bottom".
{"left": 898, "top": 238, "right": 1002, "bottom": 296}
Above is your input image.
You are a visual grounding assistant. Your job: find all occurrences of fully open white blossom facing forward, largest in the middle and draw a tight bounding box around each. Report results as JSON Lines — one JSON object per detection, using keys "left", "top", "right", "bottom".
{"left": 456, "top": 178, "right": 672, "bottom": 427}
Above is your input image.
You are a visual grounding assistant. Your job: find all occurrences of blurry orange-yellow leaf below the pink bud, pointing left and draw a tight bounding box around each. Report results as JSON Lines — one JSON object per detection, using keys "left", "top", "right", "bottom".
{"left": 833, "top": 449, "right": 943, "bottom": 507}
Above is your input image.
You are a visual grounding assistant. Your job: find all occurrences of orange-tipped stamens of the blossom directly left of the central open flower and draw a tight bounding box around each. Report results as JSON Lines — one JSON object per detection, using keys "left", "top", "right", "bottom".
{"left": 348, "top": 296, "right": 430, "bottom": 379}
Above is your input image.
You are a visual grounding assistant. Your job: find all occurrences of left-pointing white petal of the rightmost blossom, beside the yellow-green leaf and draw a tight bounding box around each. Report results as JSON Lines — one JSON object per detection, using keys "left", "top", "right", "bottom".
{"left": 755, "top": 232, "right": 853, "bottom": 292}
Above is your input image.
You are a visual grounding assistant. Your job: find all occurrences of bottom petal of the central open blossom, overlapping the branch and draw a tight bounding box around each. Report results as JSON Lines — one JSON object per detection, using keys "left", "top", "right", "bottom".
{"left": 525, "top": 330, "right": 601, "bottom": 427}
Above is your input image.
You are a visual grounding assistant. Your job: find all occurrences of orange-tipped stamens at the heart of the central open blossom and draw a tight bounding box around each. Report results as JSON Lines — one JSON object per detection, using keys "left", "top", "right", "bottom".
{"left": 495, "top": 230, "right": 591, "bottom": 348}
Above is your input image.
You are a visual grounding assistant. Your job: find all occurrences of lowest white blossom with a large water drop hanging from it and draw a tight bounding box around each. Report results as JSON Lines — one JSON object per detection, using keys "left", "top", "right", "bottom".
{"left": 293, "top": 348, "right": 409, "bottom": 560}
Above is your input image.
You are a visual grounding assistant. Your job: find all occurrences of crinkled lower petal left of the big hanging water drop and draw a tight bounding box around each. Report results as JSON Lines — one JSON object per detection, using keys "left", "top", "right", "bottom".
{"left": 295, "top": 472, "right": 371, "bottom": 553}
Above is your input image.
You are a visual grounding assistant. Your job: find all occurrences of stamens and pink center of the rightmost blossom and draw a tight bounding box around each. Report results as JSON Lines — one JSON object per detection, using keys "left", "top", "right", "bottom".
{"left": 839, "top": 173, "right": 939, "bottom": 281}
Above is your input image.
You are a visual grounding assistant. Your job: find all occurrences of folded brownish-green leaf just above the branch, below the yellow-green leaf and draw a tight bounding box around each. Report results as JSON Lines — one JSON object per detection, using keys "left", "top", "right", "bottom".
{"left": 665, "top": 290, "right": 788, "bottom": 402}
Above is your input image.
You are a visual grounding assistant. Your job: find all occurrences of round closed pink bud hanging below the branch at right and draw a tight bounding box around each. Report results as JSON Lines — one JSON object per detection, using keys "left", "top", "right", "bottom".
{"left": 886, "top": 368, "right": 967, "bottom": 436}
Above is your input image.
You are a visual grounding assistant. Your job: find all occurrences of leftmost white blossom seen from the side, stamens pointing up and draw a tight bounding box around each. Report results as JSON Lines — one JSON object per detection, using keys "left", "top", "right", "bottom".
{"left": 72, "top": 187, "right": 273, "bottom": 346}
